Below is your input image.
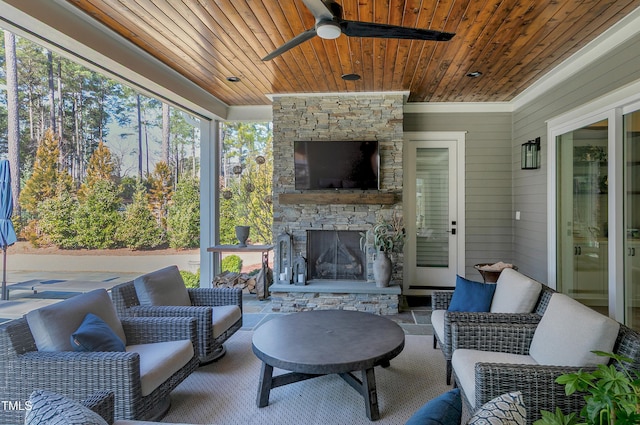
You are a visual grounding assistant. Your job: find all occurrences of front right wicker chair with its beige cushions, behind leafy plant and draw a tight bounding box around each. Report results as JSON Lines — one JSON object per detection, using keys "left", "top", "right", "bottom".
{"left": 451, "top": 293, "right": 640, "bottom": 423}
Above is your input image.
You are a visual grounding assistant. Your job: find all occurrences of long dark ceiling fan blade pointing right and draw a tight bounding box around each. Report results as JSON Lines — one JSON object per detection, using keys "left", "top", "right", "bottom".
{"left": 340, "top": 20, "right": 455, "bottom": 41}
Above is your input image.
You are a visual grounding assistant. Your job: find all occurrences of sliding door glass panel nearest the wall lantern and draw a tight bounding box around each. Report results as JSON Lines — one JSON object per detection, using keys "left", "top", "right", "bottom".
{"left": 556, "top": 120, "right": 608, "bottom": 314}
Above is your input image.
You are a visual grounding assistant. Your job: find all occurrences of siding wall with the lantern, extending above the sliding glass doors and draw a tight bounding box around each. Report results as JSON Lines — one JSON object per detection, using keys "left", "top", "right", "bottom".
{"left": 512, "top": 32, "right": 640, "bottom": 283}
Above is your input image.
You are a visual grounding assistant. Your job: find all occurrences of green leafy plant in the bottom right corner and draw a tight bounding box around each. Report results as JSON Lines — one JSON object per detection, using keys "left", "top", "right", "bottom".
{"left": 534, "top": 351, "right": 640, "bottom": 425}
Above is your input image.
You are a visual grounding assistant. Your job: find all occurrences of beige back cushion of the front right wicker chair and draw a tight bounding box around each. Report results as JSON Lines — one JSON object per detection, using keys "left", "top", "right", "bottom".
{"left": 529, "top": 293, "right": 620, "bottom": 367}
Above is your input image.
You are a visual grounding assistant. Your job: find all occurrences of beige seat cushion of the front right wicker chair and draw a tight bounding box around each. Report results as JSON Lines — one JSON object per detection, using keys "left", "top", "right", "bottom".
{"left": 451, "top": 348, "right": 536, "bottom": 408}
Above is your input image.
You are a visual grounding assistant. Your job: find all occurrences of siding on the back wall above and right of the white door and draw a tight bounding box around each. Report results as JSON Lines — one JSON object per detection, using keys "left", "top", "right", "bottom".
{"left": 404, "top": 113, "right": 514, "bottom": 280}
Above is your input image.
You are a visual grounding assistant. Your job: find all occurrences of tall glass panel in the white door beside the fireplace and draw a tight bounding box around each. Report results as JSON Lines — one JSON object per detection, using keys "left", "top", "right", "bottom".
{"left": 416, "top": 148, "right": 450, "bottom": 267}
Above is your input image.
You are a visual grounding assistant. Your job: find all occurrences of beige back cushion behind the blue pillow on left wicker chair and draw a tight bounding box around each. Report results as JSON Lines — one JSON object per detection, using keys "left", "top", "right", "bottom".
{"left": 26, "top": 289, "right": 127, "bottom": 351}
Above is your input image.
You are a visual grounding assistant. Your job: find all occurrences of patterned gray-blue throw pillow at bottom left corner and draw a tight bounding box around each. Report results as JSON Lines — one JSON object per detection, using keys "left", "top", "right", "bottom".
{"left": 24, "top": 390, "right": 108, "bottom": 425}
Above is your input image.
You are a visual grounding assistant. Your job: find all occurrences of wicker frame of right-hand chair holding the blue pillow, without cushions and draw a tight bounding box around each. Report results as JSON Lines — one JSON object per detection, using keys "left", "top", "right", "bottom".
{"left": 431, "top": 285, "right": 556, "bottom": 385}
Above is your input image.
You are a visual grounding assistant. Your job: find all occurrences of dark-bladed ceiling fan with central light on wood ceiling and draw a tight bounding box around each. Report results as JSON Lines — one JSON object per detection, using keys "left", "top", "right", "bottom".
{"left": 262, "top": 0, "right": 455, "bottom": 61}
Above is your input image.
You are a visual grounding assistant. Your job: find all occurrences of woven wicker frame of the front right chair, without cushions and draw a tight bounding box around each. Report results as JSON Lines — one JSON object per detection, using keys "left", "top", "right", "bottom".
{"left": 452, "top": 310, "right": 640, "bottom": 424}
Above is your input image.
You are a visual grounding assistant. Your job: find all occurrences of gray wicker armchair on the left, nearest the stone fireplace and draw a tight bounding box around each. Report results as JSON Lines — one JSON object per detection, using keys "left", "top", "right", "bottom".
{"left": 111, "top": 266, "right": 242, "bottom": 365}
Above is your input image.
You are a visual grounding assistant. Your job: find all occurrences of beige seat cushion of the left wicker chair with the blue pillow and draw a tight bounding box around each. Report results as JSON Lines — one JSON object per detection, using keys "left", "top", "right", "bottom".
{"left": 127, "top": 339, "right": 194, "bottom": 397}
